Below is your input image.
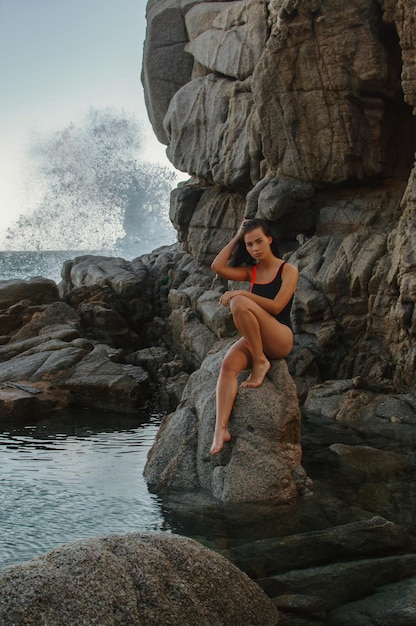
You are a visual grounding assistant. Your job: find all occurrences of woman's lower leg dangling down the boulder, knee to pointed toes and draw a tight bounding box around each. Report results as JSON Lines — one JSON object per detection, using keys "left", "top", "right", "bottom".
{"left": 211, "top": 338, "right": 251, "bottom": 454}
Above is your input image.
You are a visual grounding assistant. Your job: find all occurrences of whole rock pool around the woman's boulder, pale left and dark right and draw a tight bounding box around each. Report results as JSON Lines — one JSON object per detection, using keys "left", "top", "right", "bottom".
{"left": 0, "top": 411, "right": 416, "bottom": 565}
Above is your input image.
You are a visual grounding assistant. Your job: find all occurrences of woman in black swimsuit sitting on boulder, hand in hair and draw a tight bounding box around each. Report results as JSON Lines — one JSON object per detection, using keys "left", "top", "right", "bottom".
{"left": 211, "top": 219, "right": 298, "bottom": 454}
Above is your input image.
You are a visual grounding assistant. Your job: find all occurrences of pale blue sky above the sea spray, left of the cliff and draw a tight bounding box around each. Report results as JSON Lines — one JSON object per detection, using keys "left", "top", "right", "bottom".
{"left": 0, "top": 0, "right": 174, "bottom": 239}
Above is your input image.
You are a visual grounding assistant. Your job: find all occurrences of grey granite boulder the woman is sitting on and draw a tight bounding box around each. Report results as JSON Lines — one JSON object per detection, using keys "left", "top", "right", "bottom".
{"left": 144, "top": 346, "right": 306, "bottom": 503}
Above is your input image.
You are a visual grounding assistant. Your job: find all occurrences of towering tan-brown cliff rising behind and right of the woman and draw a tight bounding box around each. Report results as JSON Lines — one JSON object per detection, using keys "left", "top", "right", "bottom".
{"left": 143, "top": 0, "right": 416, "bottom": 393}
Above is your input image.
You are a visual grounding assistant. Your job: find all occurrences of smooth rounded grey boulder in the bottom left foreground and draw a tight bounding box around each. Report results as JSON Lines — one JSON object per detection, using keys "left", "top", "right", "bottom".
{"left": 0, "top": 533, "right": 280, "bottom": 626}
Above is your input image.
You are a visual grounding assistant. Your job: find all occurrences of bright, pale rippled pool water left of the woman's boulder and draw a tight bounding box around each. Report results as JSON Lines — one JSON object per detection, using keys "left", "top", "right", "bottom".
{"left": 0, "top": 412, "right": 168, "bottom": 566}
